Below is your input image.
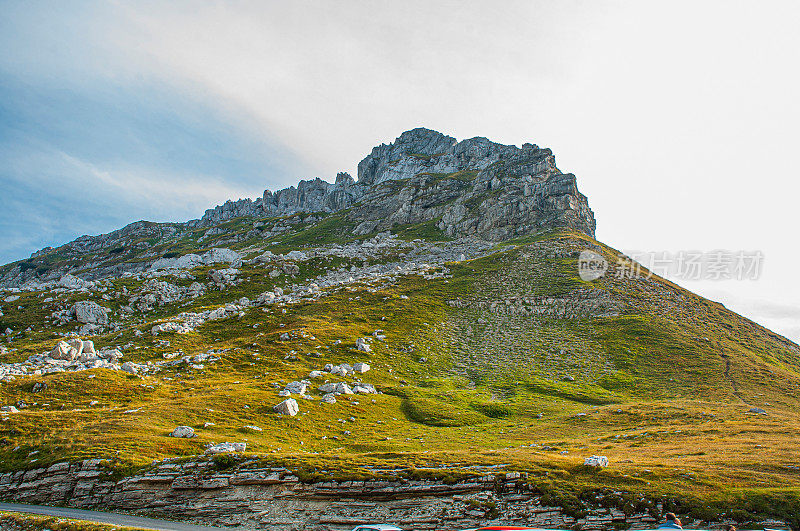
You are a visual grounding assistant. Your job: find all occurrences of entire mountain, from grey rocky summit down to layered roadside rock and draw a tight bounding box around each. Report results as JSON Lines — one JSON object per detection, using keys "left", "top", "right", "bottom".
{"left": 0, "top": 129, "right": 800, "bottom": 531}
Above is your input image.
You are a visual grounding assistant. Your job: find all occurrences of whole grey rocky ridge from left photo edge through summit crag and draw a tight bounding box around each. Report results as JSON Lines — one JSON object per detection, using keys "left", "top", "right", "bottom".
{"left": 0, "top": 129, "right": 595, "bottom": 288}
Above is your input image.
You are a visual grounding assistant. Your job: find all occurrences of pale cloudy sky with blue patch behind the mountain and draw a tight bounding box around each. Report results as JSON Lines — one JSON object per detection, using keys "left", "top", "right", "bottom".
{"left": 0, "top": 0, "right": 800, "bottom": 341}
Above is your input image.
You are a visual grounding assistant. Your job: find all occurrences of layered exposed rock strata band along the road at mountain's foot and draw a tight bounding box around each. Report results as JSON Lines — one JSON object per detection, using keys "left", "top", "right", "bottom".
{"left": 0, "top": 460, "right": 787, "bottom": 531}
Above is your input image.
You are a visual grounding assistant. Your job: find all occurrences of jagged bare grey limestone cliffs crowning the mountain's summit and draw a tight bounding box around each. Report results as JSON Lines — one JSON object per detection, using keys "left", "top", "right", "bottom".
{"left": 199, "top": 128, "right": 595, "bottom": 241}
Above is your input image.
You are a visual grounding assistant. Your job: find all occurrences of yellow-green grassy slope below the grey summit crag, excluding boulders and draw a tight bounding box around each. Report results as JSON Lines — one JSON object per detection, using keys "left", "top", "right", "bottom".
{"left": 0, "top": 231, "right": 800, "bottom": 524}
